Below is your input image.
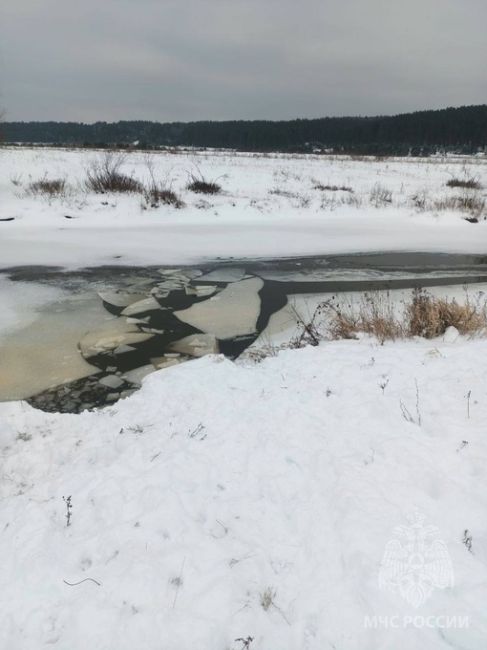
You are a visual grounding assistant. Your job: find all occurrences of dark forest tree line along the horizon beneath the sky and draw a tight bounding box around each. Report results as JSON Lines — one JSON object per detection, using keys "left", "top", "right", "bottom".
{"left": 2, "top": 104, "right": 487, "bottom": 155}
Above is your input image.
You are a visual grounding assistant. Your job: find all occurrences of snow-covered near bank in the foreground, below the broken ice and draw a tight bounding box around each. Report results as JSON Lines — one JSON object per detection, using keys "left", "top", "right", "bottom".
{"left": 0, "top": 340, "right": 487, "bottom": 650}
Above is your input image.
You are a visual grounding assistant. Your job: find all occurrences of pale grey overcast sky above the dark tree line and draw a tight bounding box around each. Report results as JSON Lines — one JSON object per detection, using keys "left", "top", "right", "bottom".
{"left": 0, "top": 0, "right": 487, "bottom": 122}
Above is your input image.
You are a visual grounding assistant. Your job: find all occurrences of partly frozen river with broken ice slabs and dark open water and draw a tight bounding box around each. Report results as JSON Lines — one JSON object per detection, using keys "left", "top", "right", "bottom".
{"left": 0, "top": 253, "right": 487, "bottom": 412}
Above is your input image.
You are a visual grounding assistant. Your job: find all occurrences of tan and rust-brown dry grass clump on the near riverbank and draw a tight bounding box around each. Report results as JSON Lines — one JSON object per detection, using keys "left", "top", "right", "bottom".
{"left": 321, "top": 289, "right": 487, "bottom": 343}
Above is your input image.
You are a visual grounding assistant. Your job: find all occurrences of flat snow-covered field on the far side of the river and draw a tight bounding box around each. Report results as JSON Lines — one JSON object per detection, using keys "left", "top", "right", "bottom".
{"left": 0, "top": 148, "right": 487, "bottom": 267}
